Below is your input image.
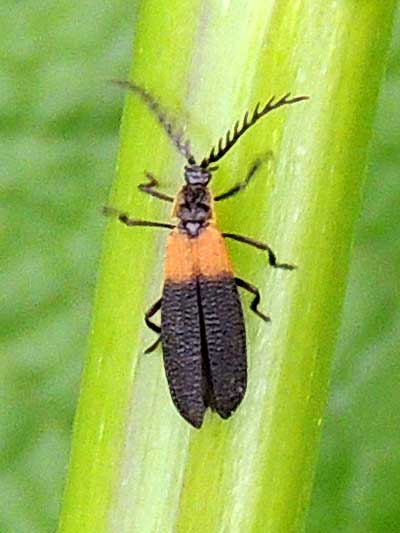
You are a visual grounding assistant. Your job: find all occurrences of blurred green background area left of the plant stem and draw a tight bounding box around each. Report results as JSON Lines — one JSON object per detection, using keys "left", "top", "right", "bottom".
{"left": 0, "top": 0, "right": 133, "bottom": 533}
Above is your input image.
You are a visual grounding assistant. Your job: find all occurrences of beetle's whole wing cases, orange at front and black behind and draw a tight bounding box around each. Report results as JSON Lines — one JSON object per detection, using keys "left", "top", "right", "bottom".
{"left": 161, "top": 225, "right": 247, "bottom": 427}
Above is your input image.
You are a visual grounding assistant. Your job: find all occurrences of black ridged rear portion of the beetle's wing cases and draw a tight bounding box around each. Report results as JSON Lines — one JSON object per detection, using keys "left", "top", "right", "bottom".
{"left": 161, "top": 277, "right": 247, "bottom": 428}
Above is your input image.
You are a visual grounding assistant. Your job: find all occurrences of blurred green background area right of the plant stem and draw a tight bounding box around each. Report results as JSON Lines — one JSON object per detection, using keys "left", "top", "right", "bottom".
{"left": 307, "top": 17, "right": 400, "bottom": 533}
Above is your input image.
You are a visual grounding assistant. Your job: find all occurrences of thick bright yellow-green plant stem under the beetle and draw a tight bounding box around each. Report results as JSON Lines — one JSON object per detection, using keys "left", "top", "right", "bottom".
{"left": 60, "top": 0, "right": 395, "bottom": 533}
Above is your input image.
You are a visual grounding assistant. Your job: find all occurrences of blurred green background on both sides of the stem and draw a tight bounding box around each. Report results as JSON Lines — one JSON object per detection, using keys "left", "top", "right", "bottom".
{"left": 0, "top": 0, "right": 400, "bottom": 533}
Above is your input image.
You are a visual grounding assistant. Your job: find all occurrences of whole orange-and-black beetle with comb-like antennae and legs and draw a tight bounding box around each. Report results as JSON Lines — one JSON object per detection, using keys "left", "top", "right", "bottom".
{"left": 105, "top": 82, "right": 307, "bottom": 428}
